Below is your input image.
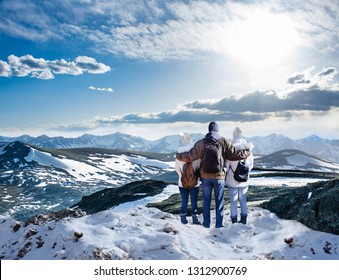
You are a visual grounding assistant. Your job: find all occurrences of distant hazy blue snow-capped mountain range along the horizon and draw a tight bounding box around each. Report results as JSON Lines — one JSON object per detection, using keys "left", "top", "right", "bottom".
{"left": 0, "top": 132, "right": 339, "bottom": 162}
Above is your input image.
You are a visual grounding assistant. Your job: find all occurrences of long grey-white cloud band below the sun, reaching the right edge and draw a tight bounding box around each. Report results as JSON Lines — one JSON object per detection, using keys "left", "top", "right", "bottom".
{"left": 51, "top": 67, "right": 339, "bottom": 127}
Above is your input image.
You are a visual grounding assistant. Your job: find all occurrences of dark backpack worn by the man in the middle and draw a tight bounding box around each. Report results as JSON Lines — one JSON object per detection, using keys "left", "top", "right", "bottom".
{"left": 201, "top": 140, "right": 224, "bottom": 173}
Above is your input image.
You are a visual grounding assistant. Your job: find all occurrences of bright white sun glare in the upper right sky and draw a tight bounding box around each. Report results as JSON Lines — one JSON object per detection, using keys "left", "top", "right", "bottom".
{"left": 227, "top": 11, "right": 299, "bottom": 70}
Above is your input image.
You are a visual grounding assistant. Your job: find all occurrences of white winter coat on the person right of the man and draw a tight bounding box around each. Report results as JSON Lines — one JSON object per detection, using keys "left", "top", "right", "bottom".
{"left": 225, "top": 138, "right": 254, "bottom": 188}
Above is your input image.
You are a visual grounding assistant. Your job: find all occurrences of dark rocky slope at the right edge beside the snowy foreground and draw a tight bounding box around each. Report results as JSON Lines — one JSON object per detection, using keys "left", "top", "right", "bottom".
{"left": 260, "top": 179, "right": 339, "bottom": 235}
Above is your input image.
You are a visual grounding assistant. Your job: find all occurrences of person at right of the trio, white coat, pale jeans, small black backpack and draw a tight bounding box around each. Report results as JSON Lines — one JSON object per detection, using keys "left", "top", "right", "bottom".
{"left": 225, "top": 127, "right": 254, "bottom": 224}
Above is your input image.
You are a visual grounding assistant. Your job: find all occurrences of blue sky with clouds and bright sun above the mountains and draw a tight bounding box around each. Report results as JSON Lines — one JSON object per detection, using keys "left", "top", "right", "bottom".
{"left": 0, "top": 0, "right": 339, "bottom": 139}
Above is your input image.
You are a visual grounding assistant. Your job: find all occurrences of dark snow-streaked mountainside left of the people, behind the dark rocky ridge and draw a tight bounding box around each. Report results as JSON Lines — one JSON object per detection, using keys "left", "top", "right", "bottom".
{"left": 0, "top": 142, "right": 174, "bottom": 220}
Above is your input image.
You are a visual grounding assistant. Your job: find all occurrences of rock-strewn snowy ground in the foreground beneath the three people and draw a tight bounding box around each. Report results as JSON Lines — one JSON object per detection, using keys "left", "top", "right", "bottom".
{"left": 0, "top": 186, "right": 339, "bottom": 260}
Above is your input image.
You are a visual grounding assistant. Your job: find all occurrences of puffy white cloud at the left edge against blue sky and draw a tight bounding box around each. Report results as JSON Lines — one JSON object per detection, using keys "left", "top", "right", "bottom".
{"left": 0, "top": 54, "right": 111, "bottom": 80}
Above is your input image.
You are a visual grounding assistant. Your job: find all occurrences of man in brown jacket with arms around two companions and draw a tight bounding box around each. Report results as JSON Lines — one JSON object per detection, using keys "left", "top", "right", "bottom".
{"left": 176, "top": 122, "right": 251, "bottom": 228}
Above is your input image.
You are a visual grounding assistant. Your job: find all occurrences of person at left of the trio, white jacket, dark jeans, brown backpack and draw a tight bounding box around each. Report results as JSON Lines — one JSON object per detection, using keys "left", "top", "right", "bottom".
{"left": 175, "top": 134, "right": 201, "bottom": 225}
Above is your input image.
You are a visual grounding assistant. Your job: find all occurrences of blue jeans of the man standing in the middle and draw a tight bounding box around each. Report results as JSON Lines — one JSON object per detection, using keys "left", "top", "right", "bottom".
{"left": 202, "top": 178, "right": 225, "bottom": 228}
